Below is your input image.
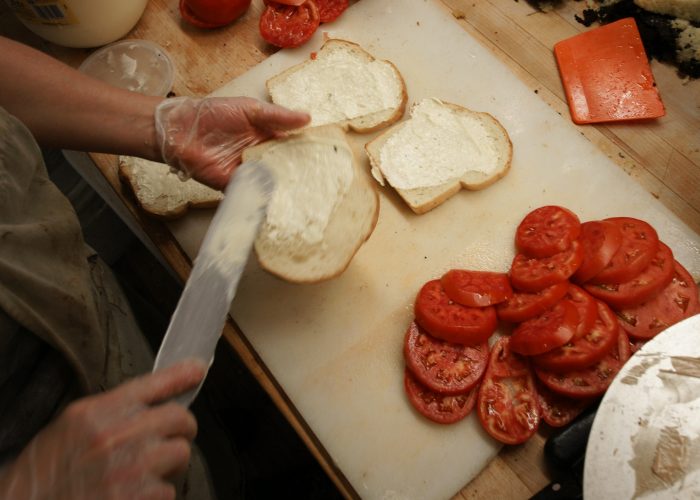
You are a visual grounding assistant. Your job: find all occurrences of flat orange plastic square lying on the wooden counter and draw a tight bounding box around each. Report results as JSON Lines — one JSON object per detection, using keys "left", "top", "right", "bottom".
{"left": 554, "top": 18, "right": 666, "bottom": 124}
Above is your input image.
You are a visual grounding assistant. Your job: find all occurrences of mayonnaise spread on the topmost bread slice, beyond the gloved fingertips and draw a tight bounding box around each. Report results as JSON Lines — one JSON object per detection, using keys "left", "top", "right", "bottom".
{"left": 270, "top": 50, "right": 403, "bottom": 126}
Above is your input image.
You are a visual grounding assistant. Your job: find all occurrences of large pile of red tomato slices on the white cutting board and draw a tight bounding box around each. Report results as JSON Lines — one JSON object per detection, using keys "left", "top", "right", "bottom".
{"left": 404, "top": 206, "right": 700, "bottom": 444}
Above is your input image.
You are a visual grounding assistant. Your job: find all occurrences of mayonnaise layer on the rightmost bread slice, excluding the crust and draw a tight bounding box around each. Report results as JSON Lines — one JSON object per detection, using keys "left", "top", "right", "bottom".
{"left": 379, "top": 99, "right": 500, "bottom": 189}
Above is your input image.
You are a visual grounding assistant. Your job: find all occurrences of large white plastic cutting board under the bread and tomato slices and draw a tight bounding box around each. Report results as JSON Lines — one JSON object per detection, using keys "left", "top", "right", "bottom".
{"left": 170, "top": 0, "right": 700, "bottom": 500}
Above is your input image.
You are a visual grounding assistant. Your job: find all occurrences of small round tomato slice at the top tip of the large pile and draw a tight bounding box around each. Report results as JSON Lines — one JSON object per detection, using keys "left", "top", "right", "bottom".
{"left": 515, "top": 205, "right": 581, "bottom": 259}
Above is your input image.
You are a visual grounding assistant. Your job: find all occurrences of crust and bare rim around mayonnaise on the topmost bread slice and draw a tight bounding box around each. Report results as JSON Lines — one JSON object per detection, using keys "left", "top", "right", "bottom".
{"left": 265, "top": 38, "right": 408, "bottom": 134}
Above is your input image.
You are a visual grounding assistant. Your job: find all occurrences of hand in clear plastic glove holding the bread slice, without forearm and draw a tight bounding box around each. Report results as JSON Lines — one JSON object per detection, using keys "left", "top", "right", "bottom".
{"left": 155, "top": 97, "right": 310, "bottom": 190}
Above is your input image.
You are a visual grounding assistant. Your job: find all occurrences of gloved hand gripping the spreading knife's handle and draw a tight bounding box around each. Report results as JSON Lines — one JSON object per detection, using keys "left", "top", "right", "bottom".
{"left": 0, "top": 361, "right": 206, "bottom": 500}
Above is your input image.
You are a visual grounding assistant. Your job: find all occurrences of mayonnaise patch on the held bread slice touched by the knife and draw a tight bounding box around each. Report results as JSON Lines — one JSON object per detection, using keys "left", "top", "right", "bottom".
{"left": 261, "top": 139, "right": 354, "bottom": 246}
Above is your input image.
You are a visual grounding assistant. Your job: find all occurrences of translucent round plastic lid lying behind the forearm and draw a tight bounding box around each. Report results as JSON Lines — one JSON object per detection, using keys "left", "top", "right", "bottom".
{"left": 78, "top": 40, "right": 175, "bottom": 96}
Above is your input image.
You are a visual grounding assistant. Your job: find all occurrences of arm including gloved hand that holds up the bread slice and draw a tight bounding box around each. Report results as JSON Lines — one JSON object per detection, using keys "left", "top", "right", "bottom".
{"left": 0, "top": 37, "right": 310, "bottom": 189}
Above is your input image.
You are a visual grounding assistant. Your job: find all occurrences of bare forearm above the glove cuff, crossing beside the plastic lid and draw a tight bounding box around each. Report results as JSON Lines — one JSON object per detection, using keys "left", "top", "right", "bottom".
{"left": 0, "top": 37, "right": 162, "bottom": 160}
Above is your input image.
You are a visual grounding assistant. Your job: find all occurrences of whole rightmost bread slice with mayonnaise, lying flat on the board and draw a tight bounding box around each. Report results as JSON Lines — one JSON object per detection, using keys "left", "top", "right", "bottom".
{"left": 365, "top": 98, "right": 513, "bottom": 214}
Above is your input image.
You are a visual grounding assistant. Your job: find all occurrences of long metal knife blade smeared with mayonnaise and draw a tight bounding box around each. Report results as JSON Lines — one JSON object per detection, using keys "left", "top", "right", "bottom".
{"left": 153, "top": 162, "right": 274, "bottom": 406}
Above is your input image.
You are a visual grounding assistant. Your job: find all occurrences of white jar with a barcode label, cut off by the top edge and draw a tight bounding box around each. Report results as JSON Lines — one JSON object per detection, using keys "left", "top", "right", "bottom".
{"left": 7, "top": 0, "right": 148, "bottom": 47}
